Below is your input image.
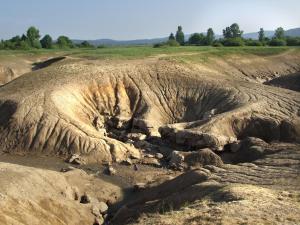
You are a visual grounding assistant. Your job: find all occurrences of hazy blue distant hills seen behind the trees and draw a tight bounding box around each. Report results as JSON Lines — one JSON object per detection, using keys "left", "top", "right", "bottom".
{"left": 72, "top": 27, "right": 300, "bottom": 46}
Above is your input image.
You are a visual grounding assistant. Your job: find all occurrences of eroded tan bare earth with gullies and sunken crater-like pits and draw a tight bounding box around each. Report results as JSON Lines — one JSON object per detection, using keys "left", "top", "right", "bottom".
{"left": 0, "top": 50, "right": 300, "bottom": 224}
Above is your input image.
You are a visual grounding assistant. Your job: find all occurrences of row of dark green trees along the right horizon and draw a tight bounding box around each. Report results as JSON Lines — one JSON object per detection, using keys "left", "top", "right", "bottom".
{"left": 154, "top": 23, "right": 300, "bottom": 47}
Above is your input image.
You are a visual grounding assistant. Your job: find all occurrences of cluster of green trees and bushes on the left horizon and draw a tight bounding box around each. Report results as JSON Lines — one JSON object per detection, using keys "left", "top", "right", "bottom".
{"left": 0, "top": 26, "right": 94, "bottom": 50}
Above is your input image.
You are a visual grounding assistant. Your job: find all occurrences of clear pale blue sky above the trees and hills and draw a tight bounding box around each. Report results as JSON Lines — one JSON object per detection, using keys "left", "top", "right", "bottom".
{"left": 0, "top": 0, "right": 300, "bottom": 40}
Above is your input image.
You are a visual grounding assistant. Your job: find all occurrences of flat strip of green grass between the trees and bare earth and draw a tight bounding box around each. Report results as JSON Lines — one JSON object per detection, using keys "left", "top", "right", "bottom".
{"left": 0, "top": 46, "right": 300, "bottom": 60}
